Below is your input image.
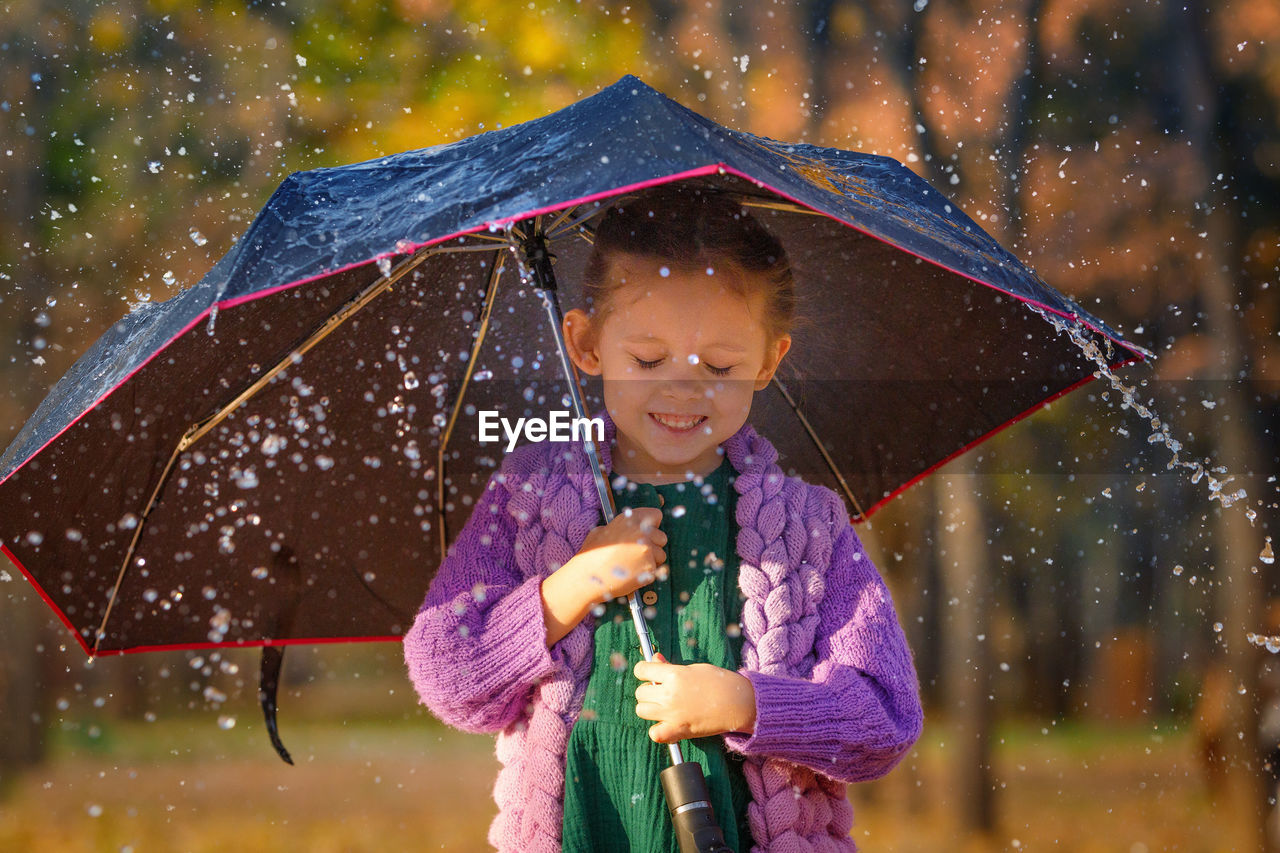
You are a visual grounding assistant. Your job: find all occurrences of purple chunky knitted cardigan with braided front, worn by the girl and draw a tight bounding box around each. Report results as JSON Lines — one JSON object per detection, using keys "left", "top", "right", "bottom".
{"left": 404, "top": 411, "right": 923, "bottom": 853}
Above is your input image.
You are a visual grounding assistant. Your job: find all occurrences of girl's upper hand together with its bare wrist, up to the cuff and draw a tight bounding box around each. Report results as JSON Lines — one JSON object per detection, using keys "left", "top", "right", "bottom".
{"left": 540, "top": 507, "right": 667, "bottom": 648}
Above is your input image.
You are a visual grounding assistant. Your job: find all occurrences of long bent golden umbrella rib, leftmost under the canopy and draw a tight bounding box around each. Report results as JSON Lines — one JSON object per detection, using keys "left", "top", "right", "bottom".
{"left": 90, "top": 247, "right": 440, "bottom": 658}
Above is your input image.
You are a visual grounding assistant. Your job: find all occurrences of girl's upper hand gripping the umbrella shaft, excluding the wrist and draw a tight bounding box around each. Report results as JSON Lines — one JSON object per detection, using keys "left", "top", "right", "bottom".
{"left": 573, "top": 507, "right": 667, "bottom": 603}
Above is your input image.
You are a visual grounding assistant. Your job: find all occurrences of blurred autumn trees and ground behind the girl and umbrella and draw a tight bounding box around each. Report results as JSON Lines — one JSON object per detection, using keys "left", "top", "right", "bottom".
{"left": 0, "top": 0, "right": 1280, "bottom": 853}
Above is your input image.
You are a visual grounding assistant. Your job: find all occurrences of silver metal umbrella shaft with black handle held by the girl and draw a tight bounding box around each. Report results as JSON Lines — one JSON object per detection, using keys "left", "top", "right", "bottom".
{"left": 517, "top": 220, "right": 732, "bottom": 853}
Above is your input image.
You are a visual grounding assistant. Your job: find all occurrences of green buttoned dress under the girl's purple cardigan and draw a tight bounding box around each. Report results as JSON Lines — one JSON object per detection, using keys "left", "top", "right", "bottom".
{"left": 562, "top": 457, "right": 753, "bottom": 853}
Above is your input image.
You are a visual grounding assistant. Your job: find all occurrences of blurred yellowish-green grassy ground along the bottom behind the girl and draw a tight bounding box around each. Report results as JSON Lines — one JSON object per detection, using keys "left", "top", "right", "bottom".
{"left": 0, "top": 688, "right": 1259, "bottom": 853}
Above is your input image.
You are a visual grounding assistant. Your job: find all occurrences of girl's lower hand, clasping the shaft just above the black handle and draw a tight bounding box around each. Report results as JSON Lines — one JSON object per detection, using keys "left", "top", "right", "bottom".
{"left": 635, "top": 654, "right": 755, "bottom": 743}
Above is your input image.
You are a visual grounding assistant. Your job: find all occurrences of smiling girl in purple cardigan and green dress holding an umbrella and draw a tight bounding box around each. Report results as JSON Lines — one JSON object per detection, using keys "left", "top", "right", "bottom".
{"left": 404, "top": 184, "right": 922, "bottom": 853}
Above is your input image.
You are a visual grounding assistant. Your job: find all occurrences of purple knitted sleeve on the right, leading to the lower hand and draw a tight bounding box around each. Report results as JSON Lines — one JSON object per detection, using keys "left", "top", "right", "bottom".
{"left": 724, "top": 493, "right": 924, "bottom": 783}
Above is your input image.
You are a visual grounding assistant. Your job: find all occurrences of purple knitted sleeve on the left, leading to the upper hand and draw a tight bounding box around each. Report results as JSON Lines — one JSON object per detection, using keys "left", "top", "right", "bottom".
{"left": 404, "top": 474, "right": 554, "bottom": 733}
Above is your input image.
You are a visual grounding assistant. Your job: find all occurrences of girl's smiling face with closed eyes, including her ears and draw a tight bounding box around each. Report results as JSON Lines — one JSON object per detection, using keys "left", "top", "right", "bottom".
{"left": 564, "top": 254, "right": 791, "bottom": 484}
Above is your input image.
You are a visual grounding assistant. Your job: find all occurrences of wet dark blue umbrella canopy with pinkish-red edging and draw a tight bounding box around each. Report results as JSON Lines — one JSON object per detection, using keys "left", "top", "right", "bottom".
{"left": 0, "top": 77, "right": 1144, "bottom": 653}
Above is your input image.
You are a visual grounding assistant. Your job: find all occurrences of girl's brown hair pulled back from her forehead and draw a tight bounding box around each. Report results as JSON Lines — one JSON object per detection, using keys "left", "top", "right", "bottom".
{"left": 582, "top": 183, "right": 796, "bottom": 342}
